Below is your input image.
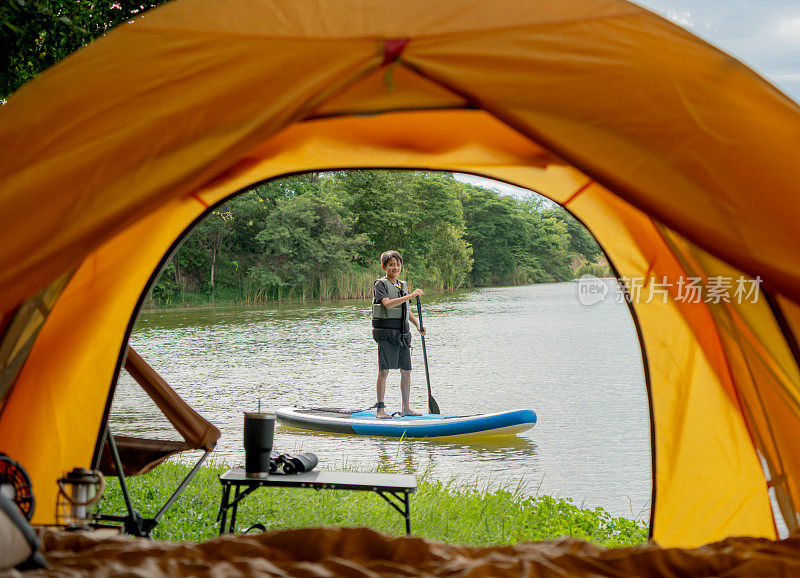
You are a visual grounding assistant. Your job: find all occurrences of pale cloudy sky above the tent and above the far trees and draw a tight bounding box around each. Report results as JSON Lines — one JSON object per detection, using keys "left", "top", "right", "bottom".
{"left": 456, "top": 0, "right": 800, "bottom": 196}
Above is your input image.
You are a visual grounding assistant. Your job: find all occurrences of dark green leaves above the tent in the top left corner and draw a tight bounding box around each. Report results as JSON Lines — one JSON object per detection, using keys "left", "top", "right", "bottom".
{"left": 0, "top": 0, "right": 166, "bottom": 99}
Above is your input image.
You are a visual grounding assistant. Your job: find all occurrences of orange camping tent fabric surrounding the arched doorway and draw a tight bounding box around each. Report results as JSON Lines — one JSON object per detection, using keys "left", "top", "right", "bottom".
{"left": 0, "top": 0, "right": 800, "bottom": 546}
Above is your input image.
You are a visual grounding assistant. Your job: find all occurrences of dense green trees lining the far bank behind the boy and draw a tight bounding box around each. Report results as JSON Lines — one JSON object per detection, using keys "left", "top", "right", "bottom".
{"left": 145, "top": 171, "right": 599, "bottom": 306}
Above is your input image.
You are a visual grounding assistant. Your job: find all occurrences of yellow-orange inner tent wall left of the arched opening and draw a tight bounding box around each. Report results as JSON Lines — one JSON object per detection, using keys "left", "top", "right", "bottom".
{"left": 0, "top": 201, "right": 208, "bottom": 523}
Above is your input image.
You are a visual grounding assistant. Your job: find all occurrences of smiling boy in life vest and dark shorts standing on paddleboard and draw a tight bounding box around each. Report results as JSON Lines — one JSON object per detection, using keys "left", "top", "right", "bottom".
{"left": 372, "top": 251, "right": 425, "bottom": 419}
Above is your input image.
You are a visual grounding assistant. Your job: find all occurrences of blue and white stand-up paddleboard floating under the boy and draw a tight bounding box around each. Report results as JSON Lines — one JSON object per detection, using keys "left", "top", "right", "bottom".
{"left": 275, "top": 407, "right": 536, "bottom": 438}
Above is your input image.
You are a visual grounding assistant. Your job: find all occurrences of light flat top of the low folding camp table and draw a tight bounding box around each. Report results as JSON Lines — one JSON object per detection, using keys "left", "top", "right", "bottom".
{"left": 219, "top": 468, "right": 417, "bottom": 492}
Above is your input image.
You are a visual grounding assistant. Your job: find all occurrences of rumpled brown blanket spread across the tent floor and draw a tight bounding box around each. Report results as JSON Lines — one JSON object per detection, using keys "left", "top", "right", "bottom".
{"left": 0, "top": 528, "right": 800, "bottom": 578}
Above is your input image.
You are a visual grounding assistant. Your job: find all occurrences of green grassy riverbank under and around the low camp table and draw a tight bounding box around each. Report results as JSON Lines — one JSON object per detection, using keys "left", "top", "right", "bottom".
{"left": 99, "top": 463, "right": 647, "bottom": 547}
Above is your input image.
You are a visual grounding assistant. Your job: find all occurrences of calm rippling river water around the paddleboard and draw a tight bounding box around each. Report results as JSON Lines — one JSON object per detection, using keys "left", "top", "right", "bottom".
{"left": 111, "top": 283, "right": 652, "bottom": 521}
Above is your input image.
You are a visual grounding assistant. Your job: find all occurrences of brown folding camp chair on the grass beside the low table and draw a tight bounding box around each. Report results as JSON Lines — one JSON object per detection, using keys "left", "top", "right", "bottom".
{"left": 96, "top": 346, "right": 220, "bottom": 537}
